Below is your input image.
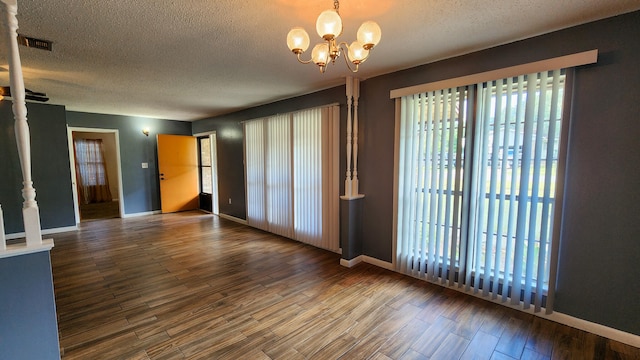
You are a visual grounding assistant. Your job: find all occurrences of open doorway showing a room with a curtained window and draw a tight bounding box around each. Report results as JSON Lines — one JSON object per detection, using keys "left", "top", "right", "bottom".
{"left": 67, "top": 127, "right": 124, "bottom": 224}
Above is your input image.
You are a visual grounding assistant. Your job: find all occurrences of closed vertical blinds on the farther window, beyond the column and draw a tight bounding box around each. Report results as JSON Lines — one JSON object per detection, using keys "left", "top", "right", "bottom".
{"left": 244, "top": 106, "right": 339, "bottom": 251}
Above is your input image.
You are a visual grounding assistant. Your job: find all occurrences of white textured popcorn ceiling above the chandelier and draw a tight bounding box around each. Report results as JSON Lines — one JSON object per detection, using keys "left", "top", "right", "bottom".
{"left": 0, "top": 0, "right": 640, "bottom": 120}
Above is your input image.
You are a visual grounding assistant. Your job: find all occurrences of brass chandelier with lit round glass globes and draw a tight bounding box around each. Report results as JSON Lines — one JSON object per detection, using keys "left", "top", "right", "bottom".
{"left": 287, "top": 0, "right": 382, "bottom": 73}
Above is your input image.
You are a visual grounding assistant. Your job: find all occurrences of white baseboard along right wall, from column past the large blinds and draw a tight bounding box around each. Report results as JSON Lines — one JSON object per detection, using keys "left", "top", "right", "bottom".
{"left": 348, "top": 255, "right": 640, "bottom": 348}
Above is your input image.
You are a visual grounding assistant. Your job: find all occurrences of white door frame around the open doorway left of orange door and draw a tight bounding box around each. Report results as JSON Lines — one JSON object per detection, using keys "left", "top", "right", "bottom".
{"left": 67, "top": 125, "right": 124, "bottom": 225}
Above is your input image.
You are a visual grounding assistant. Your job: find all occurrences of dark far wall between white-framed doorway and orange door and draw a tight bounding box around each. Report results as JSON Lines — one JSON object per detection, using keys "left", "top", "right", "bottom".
{"left": 67, "top": 111, "right": 191, "bottom": 214}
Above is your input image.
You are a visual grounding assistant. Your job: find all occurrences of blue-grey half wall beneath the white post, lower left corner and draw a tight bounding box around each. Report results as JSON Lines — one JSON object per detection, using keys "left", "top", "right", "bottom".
{"left": 0, "top": 251, "right": 60, "bottom": 360}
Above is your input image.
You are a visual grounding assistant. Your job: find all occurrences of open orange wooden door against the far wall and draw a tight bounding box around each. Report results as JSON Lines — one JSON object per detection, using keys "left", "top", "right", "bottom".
{"left": 158, "top": 135, "right": 198, "bottom": 213}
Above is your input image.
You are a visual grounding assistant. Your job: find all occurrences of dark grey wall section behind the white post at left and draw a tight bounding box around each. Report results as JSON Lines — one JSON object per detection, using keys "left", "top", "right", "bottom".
{"left": 0, "top": 100, "right": 76, "bottom": 234}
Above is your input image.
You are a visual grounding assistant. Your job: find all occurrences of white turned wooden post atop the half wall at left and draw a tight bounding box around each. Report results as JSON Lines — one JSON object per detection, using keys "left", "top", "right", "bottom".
{"left": 2, "top": 0, "right": 42, "bottom": 246}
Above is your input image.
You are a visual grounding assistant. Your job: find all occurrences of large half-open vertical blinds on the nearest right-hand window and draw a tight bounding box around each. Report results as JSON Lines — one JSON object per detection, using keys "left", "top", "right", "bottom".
{"left": 396, "top": 70, "right": 564, "bottom": 311}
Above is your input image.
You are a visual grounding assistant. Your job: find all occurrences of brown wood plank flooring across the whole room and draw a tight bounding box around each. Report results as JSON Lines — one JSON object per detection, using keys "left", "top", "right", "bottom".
{"left": 51, "top": 212, "right": 640, "bottom": 360}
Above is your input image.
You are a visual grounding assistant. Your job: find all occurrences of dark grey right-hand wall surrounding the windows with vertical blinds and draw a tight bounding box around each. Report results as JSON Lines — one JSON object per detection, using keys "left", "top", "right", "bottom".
{"left": 194, "top": 12, "right": 640, "bottom": 335}
